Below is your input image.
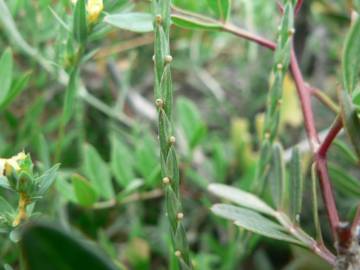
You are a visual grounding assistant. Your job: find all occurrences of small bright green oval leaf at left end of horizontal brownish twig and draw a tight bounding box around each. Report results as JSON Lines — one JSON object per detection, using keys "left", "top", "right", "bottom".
{"left": 71, "top": 174, "right": 98, "bottom": 206}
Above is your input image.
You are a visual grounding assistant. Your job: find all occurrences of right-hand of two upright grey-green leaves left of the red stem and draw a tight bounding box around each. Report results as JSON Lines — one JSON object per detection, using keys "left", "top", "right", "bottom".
{"left": 288, "top": 148, "right": 304, "bottom": 223}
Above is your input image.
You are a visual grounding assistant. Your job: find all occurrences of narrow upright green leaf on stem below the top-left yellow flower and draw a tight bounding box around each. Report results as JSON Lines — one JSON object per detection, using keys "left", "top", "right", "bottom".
{"left": 62, "top": 69, "right": 78, "bottom": 124}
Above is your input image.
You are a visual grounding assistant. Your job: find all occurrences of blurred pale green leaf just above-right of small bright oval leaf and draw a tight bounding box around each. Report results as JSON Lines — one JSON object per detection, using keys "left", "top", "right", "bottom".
{"left": 83, "top": 144, "right": 114, "bottom": 199}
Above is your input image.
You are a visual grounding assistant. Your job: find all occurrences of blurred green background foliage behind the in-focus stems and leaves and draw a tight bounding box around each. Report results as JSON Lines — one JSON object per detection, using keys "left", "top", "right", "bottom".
{"left": 0, "top": 0, "right": 360, "bottom": 270}
